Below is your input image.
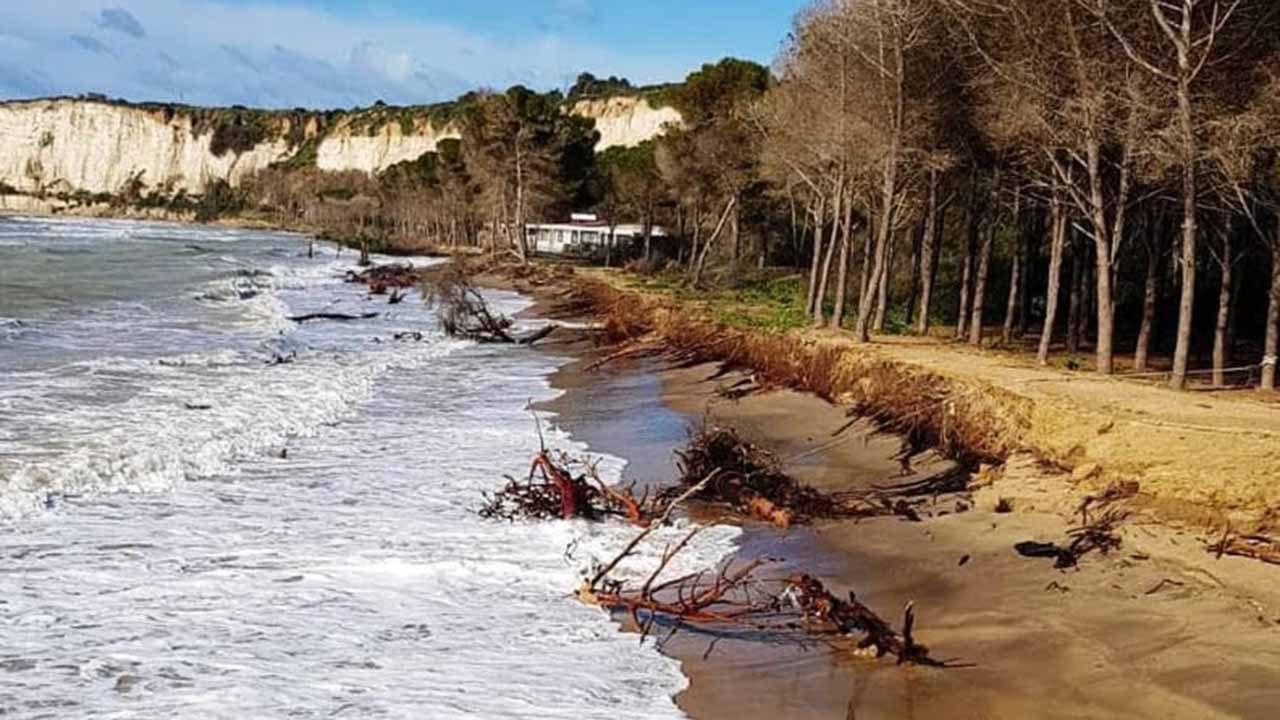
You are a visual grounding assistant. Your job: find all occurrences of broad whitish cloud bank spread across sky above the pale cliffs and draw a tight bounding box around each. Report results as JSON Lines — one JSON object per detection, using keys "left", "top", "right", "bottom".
{"left": 0, "top": 0, "right": 686, "bottom": 108}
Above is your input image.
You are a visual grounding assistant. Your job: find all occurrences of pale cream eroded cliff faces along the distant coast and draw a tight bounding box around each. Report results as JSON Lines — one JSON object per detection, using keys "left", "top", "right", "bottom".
{"left": 0, "top": 97, "right": 680, "bottom": 195}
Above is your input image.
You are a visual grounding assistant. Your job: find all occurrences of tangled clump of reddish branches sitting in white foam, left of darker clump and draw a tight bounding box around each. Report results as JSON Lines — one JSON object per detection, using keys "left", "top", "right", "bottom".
{"left": 480, "top": 448, "right": 653, "bottom": 528}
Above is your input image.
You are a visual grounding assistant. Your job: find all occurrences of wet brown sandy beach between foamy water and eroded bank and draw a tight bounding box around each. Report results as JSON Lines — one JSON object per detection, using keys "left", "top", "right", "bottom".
{"left": 508, "top": 266, "right": 1280, "bottom": 720}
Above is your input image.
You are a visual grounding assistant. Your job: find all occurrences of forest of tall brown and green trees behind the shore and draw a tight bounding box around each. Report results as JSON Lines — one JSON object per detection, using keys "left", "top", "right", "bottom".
{"left": 236, "top": 0, "right": 1280, "bottom": 389}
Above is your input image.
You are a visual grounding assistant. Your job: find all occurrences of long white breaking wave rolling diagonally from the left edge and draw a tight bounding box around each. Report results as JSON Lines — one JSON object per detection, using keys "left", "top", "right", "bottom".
{"left": 0, "top": 341, "right": 463, "bottom": 518}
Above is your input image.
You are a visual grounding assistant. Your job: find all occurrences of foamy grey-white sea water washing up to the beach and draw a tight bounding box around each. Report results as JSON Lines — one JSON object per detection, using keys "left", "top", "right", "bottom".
{"left": 0, "top": 219, "right": 733, "bottom": 719}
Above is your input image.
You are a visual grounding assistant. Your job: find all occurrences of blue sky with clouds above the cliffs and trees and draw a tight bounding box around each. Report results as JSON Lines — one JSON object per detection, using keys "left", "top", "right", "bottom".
{"left": 0, "top": 0, "right": 803, "bottom": 109}
